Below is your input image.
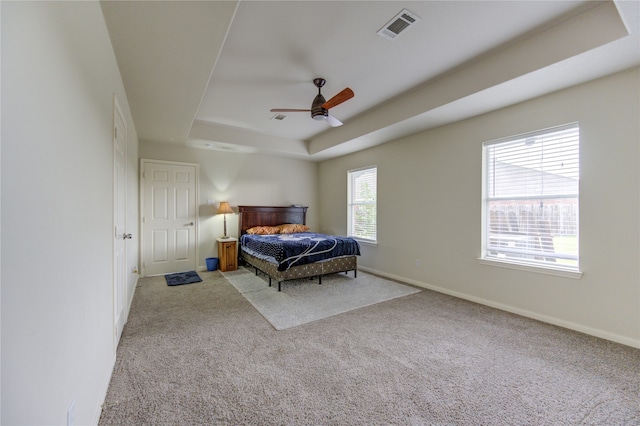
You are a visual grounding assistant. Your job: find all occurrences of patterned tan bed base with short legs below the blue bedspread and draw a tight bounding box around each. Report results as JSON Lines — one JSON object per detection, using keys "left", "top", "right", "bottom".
{"left": 240, "top": 250, "right": 358, "bottom": 291}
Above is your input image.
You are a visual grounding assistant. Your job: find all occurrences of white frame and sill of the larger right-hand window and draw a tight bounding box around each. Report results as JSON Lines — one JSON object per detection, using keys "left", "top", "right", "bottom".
{"left": 478, "top": 122, "right": 582, "bottom": 278}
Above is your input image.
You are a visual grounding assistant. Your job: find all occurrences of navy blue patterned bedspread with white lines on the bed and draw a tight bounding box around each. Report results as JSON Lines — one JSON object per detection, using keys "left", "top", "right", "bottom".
{"left": 240, "top": 232, "right": 360, "bottom": 271}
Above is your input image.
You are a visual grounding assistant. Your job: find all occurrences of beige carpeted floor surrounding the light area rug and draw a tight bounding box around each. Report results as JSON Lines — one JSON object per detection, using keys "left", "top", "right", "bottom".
{"left": 100, "top": 271, "right": 640, "bottom": 425}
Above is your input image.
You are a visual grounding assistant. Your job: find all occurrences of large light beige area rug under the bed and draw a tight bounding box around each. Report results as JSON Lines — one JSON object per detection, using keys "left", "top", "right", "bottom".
{"left": 222, "top": 267, "right": 421, "bottom": 330}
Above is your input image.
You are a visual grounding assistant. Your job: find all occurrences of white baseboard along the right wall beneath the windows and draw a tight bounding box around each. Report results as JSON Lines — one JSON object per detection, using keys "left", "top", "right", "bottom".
{"left": 358, "top": 265, "right": 640, "bottom": 349}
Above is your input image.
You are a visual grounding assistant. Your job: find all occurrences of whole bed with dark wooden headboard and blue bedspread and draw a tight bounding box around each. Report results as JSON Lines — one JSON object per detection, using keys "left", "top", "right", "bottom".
{"left": 238, "top": 206, "right": 360, "bottom": 291}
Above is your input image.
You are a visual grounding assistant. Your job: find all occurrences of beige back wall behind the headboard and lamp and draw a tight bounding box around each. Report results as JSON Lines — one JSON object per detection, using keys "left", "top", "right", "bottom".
{"left": 139, "top": 141, "right": 319, "bottom": 268}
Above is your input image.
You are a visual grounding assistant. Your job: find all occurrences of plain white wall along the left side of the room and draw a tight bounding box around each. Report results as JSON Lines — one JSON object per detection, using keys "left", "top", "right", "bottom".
{"left": 1, "top": 2, "right": 138, "bottom": 424}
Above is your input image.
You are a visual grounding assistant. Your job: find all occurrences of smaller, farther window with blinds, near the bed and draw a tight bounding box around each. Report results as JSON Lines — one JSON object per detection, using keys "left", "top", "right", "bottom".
{"left": 347, "top": 167, "right": 378, "bottom": 243}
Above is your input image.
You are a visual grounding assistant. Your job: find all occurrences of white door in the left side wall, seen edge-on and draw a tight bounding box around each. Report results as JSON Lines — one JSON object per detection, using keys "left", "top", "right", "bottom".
{"left": 113, "top": 97, "right": 131, "bottom": 348}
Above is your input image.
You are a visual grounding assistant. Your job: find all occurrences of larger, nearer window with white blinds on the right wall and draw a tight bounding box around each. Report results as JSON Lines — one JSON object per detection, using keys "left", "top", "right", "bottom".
{"left": 482, "top": 123, "right": 580, "bottom": 271}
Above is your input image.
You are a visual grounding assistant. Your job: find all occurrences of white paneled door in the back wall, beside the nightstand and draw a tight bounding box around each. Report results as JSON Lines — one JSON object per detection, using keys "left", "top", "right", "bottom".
{"left": 141, "top": 160, "right": 198, "bottom": 275}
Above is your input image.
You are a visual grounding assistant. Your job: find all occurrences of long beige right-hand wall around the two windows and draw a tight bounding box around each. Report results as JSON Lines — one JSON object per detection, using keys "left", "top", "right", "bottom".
{"left": 319, "top": 69, "right": 640, "bottom": 347}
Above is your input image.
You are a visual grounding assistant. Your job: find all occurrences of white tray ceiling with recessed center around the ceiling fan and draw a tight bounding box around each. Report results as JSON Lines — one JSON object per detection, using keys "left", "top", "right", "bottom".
{"left": 101, "top": 0, "right": 640, "bottom": 161}
